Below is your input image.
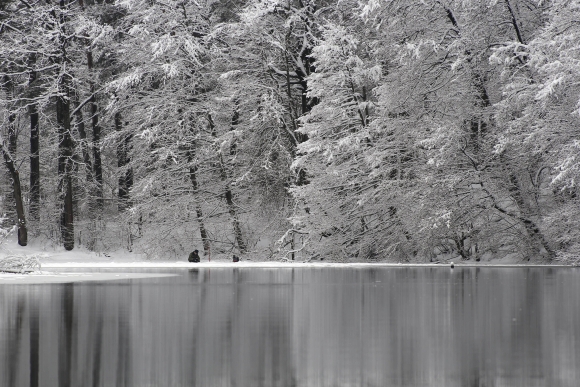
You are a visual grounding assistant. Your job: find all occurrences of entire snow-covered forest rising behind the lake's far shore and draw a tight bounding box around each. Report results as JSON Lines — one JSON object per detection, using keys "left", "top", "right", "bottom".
{"left": 0, "top": 0, "right": 580, "bottom": 263}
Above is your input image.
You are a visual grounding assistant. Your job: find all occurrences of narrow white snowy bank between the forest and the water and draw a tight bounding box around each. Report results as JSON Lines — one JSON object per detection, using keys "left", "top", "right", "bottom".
{"left": 0, "top": 239, "right": 574, "bottom": 285}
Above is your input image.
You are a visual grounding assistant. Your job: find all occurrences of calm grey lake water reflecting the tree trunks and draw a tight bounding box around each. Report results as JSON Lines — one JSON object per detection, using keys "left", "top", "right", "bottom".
{"left": 0, "top": 267, "right": 580, "bottom": 387}
